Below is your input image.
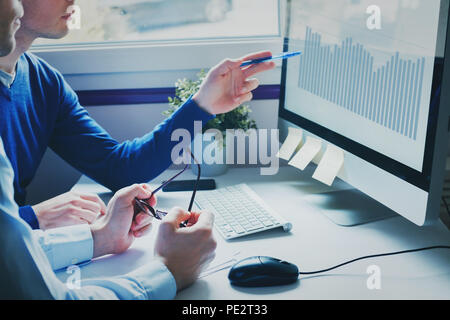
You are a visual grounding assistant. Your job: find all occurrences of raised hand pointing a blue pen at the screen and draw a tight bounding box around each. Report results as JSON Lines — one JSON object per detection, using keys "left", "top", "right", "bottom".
{"left": 193, "top": 51, "right": 275, "bottom": 114}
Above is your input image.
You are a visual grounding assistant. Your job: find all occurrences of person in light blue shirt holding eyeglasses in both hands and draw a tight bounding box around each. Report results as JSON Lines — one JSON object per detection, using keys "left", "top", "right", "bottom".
{"left": 0, "top": 136, "right": 216, "bottom": 300}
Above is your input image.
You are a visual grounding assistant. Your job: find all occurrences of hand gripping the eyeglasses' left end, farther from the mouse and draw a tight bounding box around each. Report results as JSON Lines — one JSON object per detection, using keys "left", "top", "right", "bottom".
{"left": 91, "top": 184, "right": 156, "bottom": 258}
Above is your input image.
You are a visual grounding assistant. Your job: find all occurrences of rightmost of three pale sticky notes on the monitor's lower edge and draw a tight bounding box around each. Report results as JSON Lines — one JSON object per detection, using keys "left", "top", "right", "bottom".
{"left": 313, "top": 145, "right": 344, "bottom": 186}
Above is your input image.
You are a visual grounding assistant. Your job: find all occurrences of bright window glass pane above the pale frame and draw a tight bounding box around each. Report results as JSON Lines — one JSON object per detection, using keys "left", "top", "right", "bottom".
{"left": 36, "top": 0, "right": 280, "bottom": 45}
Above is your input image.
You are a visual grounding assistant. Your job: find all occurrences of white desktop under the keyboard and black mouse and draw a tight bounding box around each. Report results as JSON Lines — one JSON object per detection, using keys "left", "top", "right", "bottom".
{"left": 58, "top": 167, "right": 450, "bottom": 300}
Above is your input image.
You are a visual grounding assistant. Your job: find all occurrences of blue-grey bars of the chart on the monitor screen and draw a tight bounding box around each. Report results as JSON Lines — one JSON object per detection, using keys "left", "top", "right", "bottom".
{"left": 298, "top": 27, "right": 425, "bottom": 140}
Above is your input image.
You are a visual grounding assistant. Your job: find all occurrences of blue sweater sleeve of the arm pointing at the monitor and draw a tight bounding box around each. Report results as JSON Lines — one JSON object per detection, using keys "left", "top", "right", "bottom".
{"left": 50, "top": 76, "right": 214, "bottom": 191}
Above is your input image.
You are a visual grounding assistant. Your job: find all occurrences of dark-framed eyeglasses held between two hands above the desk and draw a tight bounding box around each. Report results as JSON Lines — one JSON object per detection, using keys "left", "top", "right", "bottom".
{"left": 133, "top": 151, "right": 201, "bottom": 227}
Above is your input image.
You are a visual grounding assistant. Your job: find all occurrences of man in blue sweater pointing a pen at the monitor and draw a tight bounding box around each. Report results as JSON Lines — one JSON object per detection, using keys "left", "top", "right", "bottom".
{"left": 0, "top": 0, "right": 274, "bottom": 232}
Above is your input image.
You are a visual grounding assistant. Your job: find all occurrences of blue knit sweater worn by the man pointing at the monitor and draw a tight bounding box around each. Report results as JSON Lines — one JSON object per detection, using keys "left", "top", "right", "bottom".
{"left": 0, "top": 53, "right": 213, "bottom": 228}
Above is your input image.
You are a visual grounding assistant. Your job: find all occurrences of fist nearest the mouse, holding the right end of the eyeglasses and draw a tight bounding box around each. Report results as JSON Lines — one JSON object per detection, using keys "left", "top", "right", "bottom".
{"left": 155, "top": 208, "right": 217, "bottom": 291}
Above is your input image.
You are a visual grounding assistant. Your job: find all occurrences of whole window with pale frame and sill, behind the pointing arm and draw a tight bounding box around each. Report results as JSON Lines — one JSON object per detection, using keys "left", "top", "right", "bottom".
{"left": 32, "top": 0, "right": 285, "bottom": 90}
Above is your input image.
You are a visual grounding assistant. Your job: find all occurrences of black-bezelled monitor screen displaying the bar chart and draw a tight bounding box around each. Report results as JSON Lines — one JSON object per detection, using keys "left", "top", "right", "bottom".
{"left": 280, "top": 0, "right": 449, "bottom": 191}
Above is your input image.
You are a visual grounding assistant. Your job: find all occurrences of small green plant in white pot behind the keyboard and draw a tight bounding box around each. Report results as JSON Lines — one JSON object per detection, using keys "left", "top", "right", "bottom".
{"left": 163, "top": 70, "right": 257, "bottom": 177}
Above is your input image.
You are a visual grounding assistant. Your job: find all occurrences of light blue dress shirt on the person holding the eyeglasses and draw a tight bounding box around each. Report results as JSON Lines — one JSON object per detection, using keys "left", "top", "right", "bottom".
{"left": 0, "top": 138, "right": 176, "bottom": 299}
